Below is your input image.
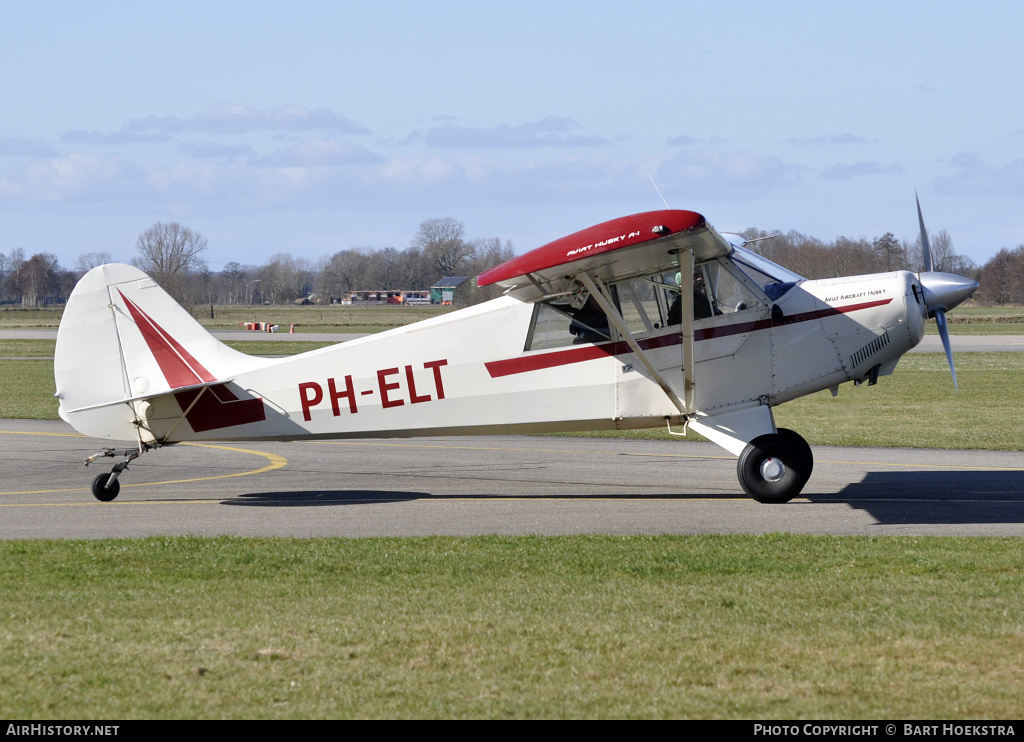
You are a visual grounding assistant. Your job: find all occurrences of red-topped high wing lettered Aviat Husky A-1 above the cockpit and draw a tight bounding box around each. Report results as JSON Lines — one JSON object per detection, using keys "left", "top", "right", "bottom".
{"left": 476, "top": 210, "right": 732, "bottom": 294}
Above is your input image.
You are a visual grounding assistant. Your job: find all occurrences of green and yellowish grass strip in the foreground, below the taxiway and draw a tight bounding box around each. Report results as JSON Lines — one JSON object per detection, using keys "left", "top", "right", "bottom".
{"left": 0, "top": 535, "right": 1024, "bottom": 719}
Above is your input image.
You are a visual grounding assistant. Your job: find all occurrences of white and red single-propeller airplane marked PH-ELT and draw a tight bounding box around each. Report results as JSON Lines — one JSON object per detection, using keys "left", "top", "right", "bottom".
{"left": 54, "top": 201, "right": 978, "bottom": 504}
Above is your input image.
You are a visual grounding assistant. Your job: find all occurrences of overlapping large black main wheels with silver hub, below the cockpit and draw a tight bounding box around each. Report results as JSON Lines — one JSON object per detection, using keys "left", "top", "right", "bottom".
{"left": 736, "top": 428, "right": 814, "bottom": 503}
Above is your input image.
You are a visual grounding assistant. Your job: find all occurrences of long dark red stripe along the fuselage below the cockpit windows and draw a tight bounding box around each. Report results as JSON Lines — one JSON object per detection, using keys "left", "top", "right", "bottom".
{"left": 483, "top": 299, "right": 892, "bottom": 379}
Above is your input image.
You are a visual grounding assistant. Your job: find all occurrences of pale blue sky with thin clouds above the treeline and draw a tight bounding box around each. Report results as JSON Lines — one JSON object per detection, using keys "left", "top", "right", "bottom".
{"left": 0, "top": 0, "right": 1024, "bottom": 270}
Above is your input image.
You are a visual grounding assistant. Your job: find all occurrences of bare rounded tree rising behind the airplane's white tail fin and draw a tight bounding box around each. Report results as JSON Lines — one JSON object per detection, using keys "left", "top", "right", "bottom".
{"left": 133, "top": 222, "right": 207, "bottom": 306}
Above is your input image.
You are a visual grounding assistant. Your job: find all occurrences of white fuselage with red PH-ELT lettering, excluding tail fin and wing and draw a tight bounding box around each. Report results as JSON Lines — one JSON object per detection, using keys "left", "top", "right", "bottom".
{"left": 128, "top": 271, "right": 924, "bottom": 442}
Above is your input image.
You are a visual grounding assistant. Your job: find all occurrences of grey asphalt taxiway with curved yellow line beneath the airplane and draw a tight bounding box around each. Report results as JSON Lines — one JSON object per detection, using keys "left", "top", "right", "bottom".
{"left": 0, "top": 420, "right": 1024, "bottom": 539}
